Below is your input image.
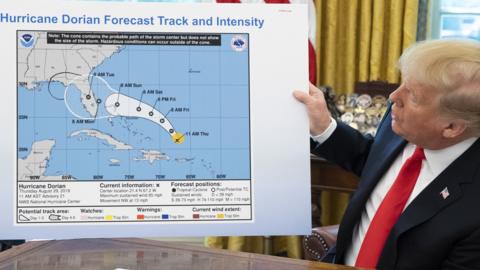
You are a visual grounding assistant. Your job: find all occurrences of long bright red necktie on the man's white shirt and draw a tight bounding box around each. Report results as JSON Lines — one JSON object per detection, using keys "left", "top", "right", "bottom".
{"left": 355, "top": 147, "right": 425, "bottom": 268}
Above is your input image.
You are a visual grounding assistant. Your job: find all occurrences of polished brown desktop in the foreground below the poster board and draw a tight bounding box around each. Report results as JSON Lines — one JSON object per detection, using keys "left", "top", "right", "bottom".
{"left": 0, "top": 238, "right": 355, "bottom": 270}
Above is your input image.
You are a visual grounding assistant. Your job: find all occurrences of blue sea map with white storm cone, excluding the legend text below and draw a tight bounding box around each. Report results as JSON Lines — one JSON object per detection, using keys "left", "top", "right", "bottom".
{"left": 17, "top": 31, "right": 251, "bottom": 181}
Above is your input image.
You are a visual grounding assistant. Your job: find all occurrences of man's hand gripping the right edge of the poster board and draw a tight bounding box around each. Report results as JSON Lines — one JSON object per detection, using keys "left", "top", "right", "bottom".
{"left": 293, "top": 84, "right": 331, "bottom": 136}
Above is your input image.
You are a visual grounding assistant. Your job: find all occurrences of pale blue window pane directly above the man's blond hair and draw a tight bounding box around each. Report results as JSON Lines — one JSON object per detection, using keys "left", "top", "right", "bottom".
{"left": 440, "top": 14, "right": 480, "bottom": 40}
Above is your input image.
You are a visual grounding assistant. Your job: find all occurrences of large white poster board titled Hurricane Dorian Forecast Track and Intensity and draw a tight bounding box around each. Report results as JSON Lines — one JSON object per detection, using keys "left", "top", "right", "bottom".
{"left": 0, "top": 0, "right": 311, "bottom": 239}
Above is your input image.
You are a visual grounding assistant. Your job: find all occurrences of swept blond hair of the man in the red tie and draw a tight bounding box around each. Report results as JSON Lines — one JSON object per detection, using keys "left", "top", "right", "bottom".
{"left": 398, "top": 39, "right": 480, "bottom": 136}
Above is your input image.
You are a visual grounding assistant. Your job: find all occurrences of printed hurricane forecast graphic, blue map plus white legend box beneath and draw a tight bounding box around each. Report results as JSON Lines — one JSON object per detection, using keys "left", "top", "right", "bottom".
{"left": 17, "top": 30, "right": 252, "bottom": 223}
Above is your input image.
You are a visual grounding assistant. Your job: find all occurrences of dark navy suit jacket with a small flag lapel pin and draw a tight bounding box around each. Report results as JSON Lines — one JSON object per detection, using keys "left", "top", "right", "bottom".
{"left": 311, "top": 107, "right": 480, "bottom": 270}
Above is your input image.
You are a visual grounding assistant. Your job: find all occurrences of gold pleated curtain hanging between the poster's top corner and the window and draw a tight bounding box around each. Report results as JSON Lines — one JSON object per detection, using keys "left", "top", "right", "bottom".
{"left": 316, "top": 0, "right": 418, "bottom": 93}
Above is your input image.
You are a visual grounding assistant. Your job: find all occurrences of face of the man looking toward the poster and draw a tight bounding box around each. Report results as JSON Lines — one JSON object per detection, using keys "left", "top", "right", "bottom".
{"left": 390, "top": 80, "right": 448, "bottom": 149}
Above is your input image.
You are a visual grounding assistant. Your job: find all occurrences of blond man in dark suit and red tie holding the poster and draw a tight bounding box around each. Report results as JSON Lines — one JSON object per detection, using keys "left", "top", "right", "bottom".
{"left": 294, "top": 40, "right": 480, "bottom": 270}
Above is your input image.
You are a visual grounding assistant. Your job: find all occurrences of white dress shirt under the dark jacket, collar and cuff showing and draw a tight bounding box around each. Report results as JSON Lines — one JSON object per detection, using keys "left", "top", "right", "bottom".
{"left": 312, "top": 119, "right": 478, "bottom": 266}
